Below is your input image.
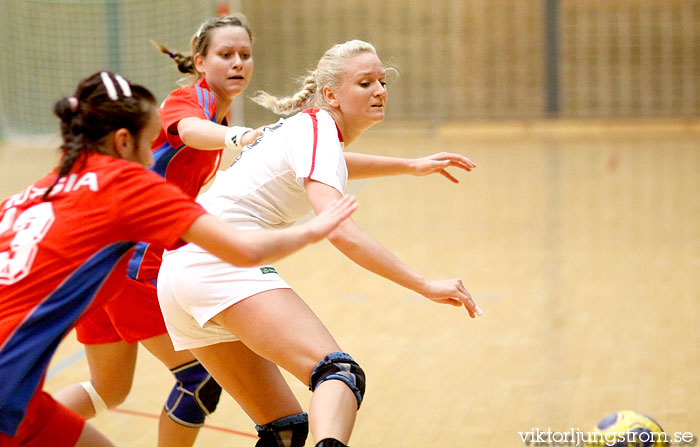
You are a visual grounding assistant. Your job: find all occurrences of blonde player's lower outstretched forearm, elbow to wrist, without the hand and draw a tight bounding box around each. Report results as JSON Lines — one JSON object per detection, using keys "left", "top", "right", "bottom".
{"left": 328, "top": 219, "right": 426, "bottom": 294}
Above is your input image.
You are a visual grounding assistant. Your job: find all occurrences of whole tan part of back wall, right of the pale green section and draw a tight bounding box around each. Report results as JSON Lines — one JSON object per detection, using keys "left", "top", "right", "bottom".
{"left": 242, "top": 0, "right": 700, "bottom": 123}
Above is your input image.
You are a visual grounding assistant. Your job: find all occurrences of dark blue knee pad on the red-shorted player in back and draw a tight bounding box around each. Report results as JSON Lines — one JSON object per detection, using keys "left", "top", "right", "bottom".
{"left": 165, "top": 360, "right": 221, "bottom": 427}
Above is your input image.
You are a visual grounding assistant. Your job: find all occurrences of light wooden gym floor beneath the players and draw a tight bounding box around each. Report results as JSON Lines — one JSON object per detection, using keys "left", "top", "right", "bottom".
{"left": 0, "top": 122, "right": 700, "bottom": 447}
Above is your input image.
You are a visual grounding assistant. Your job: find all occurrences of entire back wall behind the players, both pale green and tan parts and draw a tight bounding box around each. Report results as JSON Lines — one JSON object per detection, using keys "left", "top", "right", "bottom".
{"left": 0, "top": 0, "right": 700, "bottom": 134}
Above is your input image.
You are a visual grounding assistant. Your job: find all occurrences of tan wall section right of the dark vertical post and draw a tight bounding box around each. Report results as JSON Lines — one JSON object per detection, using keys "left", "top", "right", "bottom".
{"left": 560, "top": 0, "right": 700, "bottom": 117}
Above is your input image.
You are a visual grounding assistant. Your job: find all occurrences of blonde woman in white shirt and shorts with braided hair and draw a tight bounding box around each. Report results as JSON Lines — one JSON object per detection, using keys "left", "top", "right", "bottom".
{"left": 158, "top": 40, "right": 481, "bottom": 447}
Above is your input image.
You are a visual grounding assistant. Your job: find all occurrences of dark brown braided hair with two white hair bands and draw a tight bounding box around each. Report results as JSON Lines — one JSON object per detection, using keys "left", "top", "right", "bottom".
{"left": 44, "top": 71, "right": 156, "bottom": 198}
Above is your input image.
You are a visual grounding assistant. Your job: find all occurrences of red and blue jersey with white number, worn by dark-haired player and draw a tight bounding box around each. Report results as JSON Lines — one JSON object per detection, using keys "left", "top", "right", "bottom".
{"left": 0, "top": 153, "right": 204, "bottom": 435}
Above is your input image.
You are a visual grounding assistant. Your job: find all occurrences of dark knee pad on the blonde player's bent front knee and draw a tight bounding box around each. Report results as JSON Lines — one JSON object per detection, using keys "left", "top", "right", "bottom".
{"left": 309, "top": 352, "right": 365, "bottom": 410}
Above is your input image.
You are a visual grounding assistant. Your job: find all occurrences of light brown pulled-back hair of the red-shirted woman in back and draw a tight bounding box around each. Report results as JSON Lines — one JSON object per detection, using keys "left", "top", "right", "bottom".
{"left": 151, "top": 13, "right": 253, "bottom": 81}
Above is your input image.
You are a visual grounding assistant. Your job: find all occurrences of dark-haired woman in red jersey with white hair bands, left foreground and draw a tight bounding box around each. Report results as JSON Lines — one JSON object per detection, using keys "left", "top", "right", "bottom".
{"left": 0, "top": 72, "right": 356, "bottom": 447}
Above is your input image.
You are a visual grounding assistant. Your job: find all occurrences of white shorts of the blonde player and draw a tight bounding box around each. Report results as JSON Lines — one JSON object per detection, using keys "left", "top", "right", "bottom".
{"left": 158, "top": 250, "right": 291, "bottom": 351}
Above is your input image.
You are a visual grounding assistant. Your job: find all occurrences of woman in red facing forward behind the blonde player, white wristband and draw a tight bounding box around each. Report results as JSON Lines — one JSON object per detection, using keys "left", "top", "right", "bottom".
{"left": 54, "top": 14, "right": 258, "bottom": 447}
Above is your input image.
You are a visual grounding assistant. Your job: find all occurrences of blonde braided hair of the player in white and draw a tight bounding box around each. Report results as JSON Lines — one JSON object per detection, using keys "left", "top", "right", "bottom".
{"left": 252, "top": 40, "right": 377, "bottom": 115}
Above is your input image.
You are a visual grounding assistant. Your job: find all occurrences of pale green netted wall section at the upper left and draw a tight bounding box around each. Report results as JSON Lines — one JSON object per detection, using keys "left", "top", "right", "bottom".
{"left": 0, "top": 0, "right": 215, "bottom": 135}
